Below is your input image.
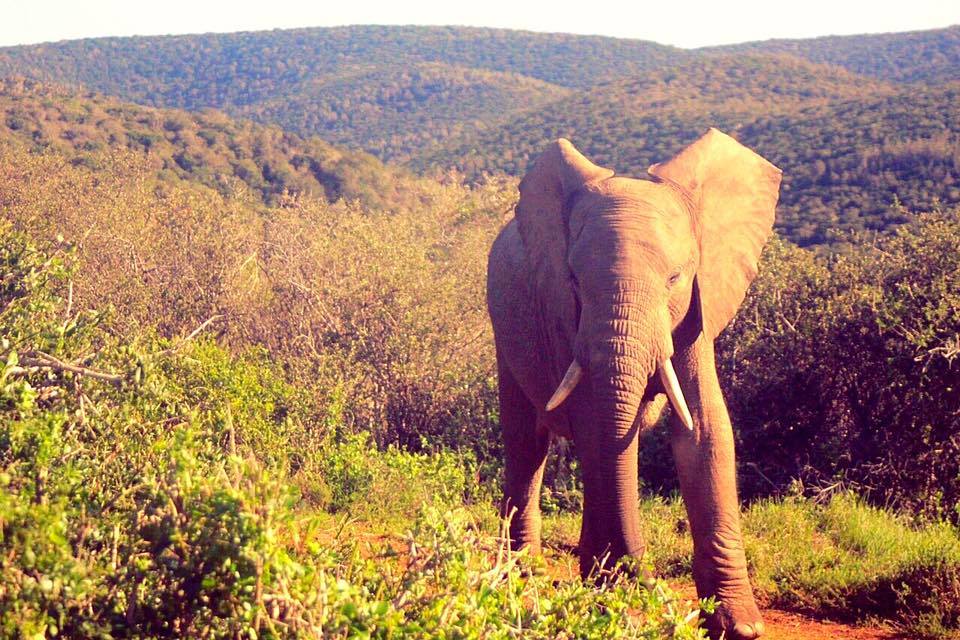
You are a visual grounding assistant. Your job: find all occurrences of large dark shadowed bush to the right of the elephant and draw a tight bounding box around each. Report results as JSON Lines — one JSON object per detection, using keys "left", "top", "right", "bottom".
{"left": 718, "top": 209, "right": 960, "bottom": 521}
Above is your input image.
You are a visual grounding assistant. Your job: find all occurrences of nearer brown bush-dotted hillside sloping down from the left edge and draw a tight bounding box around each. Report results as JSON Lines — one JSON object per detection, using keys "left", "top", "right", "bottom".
{"left": 0, "top": 78, "right": 407, "bottom": 206}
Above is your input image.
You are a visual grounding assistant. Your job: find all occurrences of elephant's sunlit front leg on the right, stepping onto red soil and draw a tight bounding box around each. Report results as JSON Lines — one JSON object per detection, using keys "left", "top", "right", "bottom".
{"left": 670, "top": 336, "right": 763, "bottom": 640}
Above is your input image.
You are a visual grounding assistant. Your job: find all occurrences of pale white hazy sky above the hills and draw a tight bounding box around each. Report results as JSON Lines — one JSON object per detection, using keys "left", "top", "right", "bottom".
{"left": 0, "top": 0, "right": 960, "bottom": 47}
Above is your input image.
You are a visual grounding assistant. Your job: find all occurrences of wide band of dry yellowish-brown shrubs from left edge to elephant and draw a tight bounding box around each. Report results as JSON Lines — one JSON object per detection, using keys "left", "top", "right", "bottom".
{"left": 0, "top": 149, "right": 515, "bottom": 458}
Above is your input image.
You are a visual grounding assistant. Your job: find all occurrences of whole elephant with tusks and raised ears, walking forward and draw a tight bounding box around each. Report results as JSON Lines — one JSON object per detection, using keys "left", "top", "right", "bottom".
{"left": 487, "top": 129, "right": 782, "bottom": 639}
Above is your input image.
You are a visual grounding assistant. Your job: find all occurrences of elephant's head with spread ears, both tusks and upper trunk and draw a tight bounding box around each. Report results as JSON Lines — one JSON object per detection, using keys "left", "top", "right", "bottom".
{"left": 516, "top": 129, "right": 781, "bottom": 439}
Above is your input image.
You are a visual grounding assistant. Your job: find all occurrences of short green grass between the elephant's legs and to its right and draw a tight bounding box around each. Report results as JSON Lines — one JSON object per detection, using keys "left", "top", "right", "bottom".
{"left": 544, "top": 493, "right": 960, "bottom": 638}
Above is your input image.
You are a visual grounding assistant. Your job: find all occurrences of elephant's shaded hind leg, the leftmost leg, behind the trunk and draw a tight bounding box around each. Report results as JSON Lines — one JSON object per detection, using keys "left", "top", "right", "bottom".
{"left": 498, "top": 362, "right": 550, "bottom": 553}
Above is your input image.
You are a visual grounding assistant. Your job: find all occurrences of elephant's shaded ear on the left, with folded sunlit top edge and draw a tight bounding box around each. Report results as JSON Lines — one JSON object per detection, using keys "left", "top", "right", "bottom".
{"left": 516, "top": 138, "right": 613, "bottom": 350}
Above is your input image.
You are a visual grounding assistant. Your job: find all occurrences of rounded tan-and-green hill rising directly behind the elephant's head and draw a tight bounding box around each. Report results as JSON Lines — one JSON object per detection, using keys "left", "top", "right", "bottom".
{"left": 411, "top": 55, "right": 893, "bottom": 174}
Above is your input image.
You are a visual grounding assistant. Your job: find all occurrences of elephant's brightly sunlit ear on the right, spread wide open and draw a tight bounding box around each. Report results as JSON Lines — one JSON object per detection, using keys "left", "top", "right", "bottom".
{"left": 648, "top": 129, "right": 783, "bottom": 339}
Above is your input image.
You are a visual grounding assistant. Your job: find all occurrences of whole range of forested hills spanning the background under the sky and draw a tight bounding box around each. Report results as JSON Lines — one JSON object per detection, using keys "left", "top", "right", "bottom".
{"left": 0, "top": 26, "right": 960, "bottom": 245}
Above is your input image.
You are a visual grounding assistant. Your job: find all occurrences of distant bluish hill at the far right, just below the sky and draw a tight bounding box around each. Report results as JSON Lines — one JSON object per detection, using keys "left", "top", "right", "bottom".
{"left": 716, "top": 25, "right": 960, "bottom": 83}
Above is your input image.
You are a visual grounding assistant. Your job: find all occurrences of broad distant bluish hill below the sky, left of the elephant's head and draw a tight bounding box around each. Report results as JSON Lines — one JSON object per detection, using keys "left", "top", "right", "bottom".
{"left": 0, "top": 26, "right": 690, "bottom": 158}
